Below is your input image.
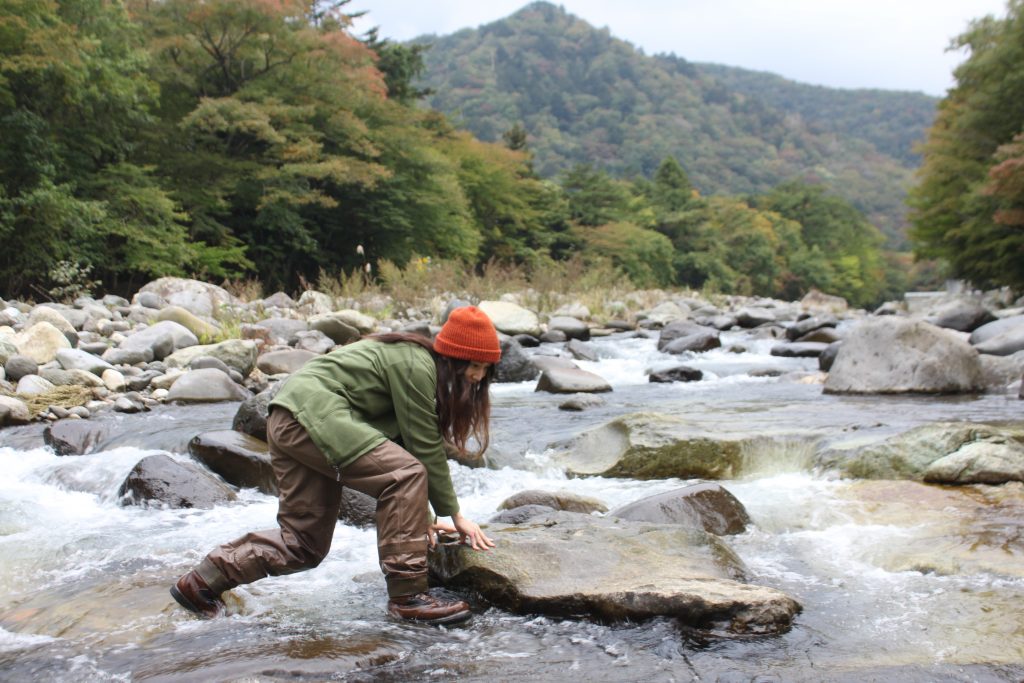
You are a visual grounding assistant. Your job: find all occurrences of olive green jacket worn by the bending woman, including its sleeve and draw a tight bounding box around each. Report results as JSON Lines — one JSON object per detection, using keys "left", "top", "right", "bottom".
{"left": 270, "top": 340, "right": 459, "bottom": 516}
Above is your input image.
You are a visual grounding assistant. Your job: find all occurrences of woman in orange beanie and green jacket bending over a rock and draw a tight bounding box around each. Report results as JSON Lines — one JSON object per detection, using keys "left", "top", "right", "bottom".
{"left": 171, "top": 306, "right": 501, "bottom": 624}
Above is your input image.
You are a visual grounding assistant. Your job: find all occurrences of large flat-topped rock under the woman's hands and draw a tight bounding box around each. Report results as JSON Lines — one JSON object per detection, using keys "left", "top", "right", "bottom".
{"left": 429, "top": 512, "right": 801, "bottom": 635}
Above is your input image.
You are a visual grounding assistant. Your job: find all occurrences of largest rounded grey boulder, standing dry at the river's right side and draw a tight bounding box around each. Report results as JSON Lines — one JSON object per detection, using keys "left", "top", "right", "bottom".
{"left": 824, "top": 317, "right": 982, "bottom": 393}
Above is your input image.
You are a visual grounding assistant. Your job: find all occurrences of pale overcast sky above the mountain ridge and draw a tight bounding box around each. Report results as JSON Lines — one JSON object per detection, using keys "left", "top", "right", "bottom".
{"left": 345, "top": 0, "right": 1006, "bottom": 95}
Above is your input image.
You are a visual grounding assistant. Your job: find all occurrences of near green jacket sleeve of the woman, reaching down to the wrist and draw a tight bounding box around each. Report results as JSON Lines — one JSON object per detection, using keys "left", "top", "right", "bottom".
{"left": 388, "top": 353, "right": 459, "bottom": 517}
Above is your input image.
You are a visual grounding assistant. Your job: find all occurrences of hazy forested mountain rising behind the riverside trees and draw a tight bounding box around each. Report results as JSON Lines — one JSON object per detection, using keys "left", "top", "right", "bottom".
{"left": 417, "top": 2, "right": 936, "bottom": 248}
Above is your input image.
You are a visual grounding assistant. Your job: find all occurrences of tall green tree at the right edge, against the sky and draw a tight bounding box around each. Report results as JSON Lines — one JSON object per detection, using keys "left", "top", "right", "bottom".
{"left": 910, "top": 0, "right": 1024, "bottom": 289}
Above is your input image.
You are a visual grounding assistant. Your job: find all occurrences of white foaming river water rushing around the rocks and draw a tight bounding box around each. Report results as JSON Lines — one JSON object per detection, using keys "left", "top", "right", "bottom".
{"left": 0, "top": 334, "right": 1024, "bottom": 682}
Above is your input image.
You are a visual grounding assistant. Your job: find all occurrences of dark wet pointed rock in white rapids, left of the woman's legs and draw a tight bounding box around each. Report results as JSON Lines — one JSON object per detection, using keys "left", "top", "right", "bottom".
{"left": 118, "top": 453, "right": 238, "bottom": 509}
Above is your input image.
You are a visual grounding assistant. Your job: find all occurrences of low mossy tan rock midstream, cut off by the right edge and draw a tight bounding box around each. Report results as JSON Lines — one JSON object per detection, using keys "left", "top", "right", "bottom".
{"left": 818, "top": 422, "right": 1024, "bottom": 483}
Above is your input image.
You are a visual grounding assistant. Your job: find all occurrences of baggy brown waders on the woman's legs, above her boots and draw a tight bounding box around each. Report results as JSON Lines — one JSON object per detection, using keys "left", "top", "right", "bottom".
{"left": 196, "top": 407, "right": 428, "bottom": 597}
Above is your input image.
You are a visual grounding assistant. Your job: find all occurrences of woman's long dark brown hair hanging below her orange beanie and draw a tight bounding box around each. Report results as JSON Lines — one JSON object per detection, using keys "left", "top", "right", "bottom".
{"left": 367, "top": 332, "right": 495, "bottom": 458}
